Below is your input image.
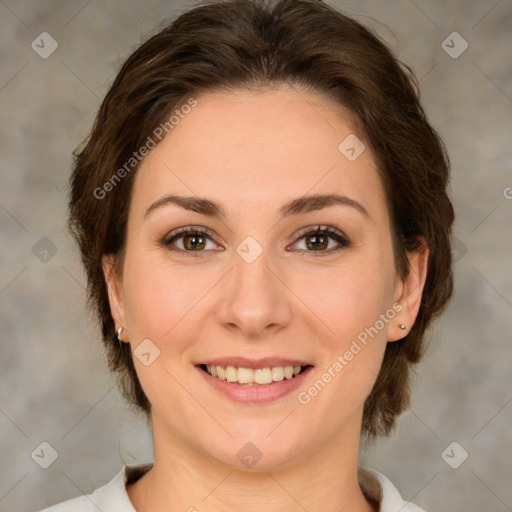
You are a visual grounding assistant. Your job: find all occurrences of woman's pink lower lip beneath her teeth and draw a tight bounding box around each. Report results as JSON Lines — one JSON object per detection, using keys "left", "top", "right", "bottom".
{"left": 196, "top": 366, "right": 313, "bottom": 403}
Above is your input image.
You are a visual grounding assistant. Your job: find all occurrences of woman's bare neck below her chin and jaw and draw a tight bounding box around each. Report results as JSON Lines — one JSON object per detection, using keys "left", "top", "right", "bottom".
{"left": 127, "top": 415, "right": 376, "bottom": 512}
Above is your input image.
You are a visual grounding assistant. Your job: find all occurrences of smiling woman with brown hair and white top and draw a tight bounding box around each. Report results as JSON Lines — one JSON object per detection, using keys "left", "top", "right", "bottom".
{"left": 42, "top": 0, "right": 453, "bottom": 512}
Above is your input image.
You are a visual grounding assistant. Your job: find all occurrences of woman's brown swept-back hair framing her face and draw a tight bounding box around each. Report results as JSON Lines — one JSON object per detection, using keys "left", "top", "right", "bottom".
{"left": 69, "top": 0, "right": 454, "bottom": 438}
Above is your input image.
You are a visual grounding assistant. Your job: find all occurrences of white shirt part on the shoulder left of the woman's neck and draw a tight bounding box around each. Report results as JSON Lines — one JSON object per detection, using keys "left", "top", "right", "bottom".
{"left": 36, "top": 463, "right": 152, "bottom": 512}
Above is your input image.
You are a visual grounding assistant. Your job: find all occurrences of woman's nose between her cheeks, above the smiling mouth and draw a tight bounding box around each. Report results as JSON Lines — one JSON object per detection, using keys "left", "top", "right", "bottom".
{"left": 218, "top": 250, "right": 293, "bottom": 341}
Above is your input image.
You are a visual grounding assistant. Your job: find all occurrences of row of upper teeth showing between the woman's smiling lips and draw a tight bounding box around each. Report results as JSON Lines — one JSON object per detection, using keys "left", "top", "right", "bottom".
{"left": 199, "top": 364, "right": 311, "bottom": 386}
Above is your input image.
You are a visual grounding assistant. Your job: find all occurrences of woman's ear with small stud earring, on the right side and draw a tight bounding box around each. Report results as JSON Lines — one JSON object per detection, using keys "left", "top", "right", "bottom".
{"left": 388, "top": 239, "right": 429, "bottom": 341}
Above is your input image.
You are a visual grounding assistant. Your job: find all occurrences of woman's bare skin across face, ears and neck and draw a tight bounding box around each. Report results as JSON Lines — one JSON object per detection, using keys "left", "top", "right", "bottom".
{"left": 104, "top": 86, "right": 428, "bottom": 512}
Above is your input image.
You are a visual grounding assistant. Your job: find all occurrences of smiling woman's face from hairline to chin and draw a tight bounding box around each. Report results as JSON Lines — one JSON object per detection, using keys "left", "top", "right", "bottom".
{"left": 105, "top": 86, "right": 421, "bottom": 469}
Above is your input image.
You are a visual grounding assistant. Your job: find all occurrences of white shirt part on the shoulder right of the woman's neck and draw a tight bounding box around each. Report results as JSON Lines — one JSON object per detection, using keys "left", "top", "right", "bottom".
{"left": 358, "top": 466, "right": 426, "bottom": 512}
